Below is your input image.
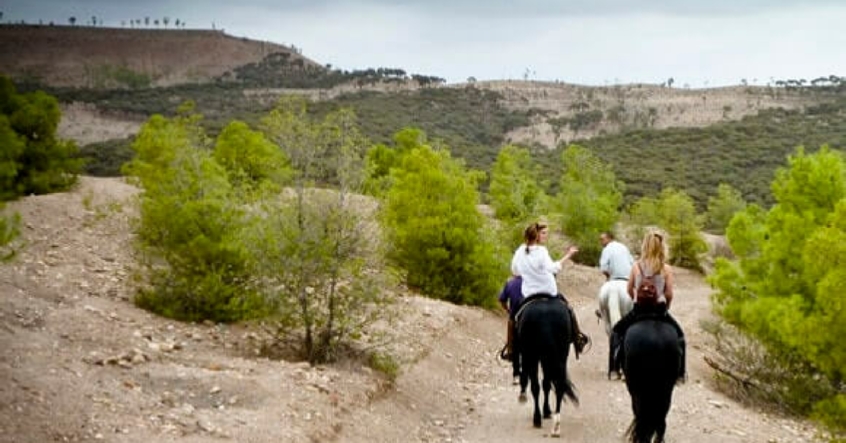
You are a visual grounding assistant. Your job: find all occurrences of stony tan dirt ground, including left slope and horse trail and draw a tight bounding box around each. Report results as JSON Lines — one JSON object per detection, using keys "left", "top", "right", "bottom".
{"left": 0, "top": 178, "right": 828, "bottom": 443}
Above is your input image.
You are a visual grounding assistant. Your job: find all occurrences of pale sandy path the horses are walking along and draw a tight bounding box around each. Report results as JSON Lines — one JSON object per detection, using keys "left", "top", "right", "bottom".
{"left": 463, "top": 269, "right": 814, "bottom": 443}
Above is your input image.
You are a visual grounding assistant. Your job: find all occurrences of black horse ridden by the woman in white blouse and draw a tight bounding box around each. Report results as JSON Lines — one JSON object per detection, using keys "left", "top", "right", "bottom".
{"left": 516, "top": 297, "right": 579, "bottom": 437}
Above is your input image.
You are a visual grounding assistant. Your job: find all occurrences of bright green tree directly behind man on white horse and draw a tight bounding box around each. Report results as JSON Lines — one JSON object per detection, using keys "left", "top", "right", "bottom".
{"left": 555, "top": 145, "right": 623, "bottom": 265}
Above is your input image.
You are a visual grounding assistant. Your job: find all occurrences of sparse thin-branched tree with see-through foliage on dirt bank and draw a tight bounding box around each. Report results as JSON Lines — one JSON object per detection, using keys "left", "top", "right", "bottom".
{"left": 258, "top": 99, "right": 392, "bottom": 363}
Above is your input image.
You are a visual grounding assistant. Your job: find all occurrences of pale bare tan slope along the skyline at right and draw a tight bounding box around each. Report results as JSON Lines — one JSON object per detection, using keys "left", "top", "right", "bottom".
{"left": 474, "top": 81, "right": 836, "bottom": 148}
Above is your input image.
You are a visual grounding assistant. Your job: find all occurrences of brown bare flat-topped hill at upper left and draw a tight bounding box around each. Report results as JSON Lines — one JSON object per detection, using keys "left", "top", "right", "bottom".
{"left": 0, "top": 25, "right": 323, "bottom": 89}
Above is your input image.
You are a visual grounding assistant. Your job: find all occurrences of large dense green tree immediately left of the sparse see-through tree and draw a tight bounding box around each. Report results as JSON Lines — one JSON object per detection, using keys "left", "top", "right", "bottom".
{"left": 124, "top": 106, "right": 262, "bottom": 321}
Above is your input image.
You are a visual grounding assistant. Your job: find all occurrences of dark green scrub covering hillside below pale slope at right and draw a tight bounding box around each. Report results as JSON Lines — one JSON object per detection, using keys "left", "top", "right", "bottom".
{"left": 538, "top": 98, "right": 846, "bottom": 209}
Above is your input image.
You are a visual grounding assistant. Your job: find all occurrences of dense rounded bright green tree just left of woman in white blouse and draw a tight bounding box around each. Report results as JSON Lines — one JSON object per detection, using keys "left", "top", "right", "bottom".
{"left": 382, "top": 130, "right": 503, "bottom": 305}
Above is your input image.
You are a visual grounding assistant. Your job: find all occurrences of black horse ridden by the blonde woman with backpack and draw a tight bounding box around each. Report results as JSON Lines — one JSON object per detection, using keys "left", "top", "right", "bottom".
{"left": 623, "top": 318, "right": 684, "bottom": 443}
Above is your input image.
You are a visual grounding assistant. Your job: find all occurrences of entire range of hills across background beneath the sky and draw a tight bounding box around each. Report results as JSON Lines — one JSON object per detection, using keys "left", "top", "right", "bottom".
{"left": 0, "top": 25, "right": 846, "bottom": 208}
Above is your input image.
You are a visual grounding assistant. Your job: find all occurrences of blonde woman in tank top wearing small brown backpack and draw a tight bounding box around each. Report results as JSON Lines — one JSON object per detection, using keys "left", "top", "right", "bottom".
{"left": 611, "top": 232, "right": 686, "bottom": 381}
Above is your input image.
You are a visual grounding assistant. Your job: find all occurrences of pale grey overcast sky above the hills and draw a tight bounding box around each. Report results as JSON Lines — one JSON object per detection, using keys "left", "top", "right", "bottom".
{"left": 6, "top": 0, "right": 846, "bottom": 88}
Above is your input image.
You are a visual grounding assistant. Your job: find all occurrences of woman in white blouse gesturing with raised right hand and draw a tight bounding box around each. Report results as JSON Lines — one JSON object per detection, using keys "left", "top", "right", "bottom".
{"left": 511, "top": 223, "right": 589, "bottom": 358}
